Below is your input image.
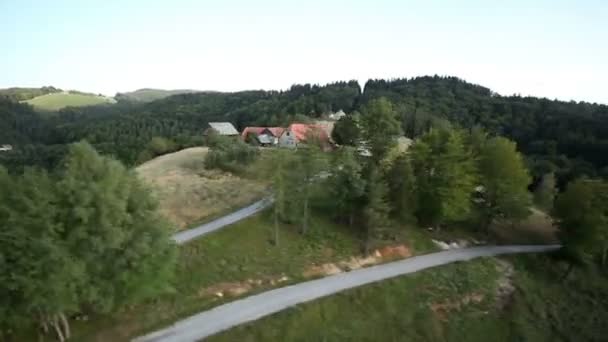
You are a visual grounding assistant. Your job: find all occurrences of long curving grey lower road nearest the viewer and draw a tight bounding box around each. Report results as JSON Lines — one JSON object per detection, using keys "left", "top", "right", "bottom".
{"left": 134, "top": 245, "right": 560, "bottom": 342}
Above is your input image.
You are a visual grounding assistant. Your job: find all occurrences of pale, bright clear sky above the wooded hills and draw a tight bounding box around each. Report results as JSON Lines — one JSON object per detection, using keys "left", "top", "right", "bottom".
{"left": 0, "top": 0, "right": 608, "bottom": 103}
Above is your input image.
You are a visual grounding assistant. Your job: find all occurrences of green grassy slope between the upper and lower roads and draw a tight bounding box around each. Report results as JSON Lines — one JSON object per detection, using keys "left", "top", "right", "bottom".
{"left": 61, "top": 212, "right": 424, "bottom": 341}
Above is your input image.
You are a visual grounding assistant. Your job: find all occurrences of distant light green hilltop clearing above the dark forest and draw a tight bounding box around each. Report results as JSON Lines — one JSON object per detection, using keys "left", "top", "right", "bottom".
{"left": 24, "top": 92, "right": 115, "bottom": 111}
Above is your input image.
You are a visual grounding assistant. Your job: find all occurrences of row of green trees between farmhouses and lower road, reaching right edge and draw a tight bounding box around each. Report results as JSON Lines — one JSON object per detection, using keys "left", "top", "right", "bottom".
{"left": 255, "top": 98, "right": 608, "bottom": 272}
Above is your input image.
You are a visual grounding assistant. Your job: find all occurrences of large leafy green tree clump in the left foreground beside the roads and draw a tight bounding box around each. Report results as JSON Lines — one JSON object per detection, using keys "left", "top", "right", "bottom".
{"left": 0, "top": 143, "right": 176, "bottom": 341}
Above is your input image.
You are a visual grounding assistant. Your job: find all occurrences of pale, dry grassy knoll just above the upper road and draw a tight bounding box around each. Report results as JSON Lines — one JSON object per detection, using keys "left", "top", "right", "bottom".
{"left": 136, "top": 147, "right": 266, "bottom": 229}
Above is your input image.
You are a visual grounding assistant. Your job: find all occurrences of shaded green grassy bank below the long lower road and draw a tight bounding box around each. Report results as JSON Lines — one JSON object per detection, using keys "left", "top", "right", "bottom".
{"left": 208, "top": 256, "right": 608, "bottom": 342}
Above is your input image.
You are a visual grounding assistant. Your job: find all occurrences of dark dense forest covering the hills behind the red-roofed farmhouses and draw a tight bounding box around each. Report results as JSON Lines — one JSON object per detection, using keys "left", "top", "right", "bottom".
{"left": 0, "top": 76, "right": 608, "bottom": 184}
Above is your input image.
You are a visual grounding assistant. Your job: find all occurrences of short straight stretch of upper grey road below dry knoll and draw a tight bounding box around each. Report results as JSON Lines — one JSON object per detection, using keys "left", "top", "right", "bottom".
{"left": 173, "top": 198, "right": 272, "bottom": 245}
